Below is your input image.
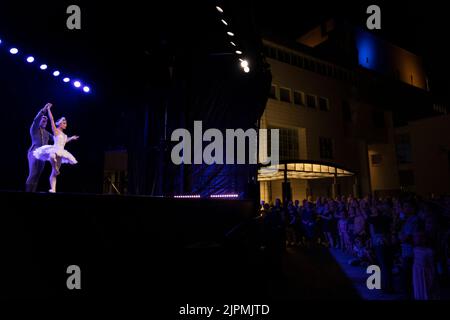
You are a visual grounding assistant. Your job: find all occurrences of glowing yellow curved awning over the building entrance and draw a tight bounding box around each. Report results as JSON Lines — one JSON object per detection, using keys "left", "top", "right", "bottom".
{"left": 258, "top": 161, "right": 354, "bottom": 181}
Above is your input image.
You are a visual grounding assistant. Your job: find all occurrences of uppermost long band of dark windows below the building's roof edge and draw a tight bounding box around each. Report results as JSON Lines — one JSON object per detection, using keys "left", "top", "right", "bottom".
{"left": 264, "top": 45, "right": 357, "bottom": 83}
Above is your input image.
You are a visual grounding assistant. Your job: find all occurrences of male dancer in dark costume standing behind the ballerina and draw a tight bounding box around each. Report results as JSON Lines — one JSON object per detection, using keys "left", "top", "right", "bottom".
{"left": 25, "top": 103, "right": 53, "bottom": 192}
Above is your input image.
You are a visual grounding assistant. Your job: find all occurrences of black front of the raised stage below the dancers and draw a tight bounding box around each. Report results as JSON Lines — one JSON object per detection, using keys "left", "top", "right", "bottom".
{"left": 0, "top": 192, "right": 256, "bottom": 298}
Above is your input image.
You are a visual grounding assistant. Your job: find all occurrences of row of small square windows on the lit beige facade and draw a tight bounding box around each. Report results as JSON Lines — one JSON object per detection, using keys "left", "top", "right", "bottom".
{"left": 270, "top": 85, "right": 330, "bottom": 111}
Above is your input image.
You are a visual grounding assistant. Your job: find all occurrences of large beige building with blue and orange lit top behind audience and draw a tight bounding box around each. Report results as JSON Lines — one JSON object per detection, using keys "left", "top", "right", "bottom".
{"left": 258, "top": 20, "right": 440, "bottom": 202}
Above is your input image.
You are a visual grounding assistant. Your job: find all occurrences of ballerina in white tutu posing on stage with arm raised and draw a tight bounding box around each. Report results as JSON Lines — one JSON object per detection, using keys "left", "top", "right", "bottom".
{"left": 33, "top": 104, "right": 79, "bottom": 193}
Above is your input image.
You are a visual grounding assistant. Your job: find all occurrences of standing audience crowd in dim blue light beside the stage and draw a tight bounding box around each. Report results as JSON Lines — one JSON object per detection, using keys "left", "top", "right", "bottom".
{"left": 261, "top": 192, "right": 450, "bottom": 300}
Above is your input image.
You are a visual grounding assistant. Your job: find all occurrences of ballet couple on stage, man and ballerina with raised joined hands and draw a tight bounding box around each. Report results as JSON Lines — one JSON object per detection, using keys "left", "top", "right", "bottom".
{"left": 26, "top": 103, "right": 78, "bottom": 193}
